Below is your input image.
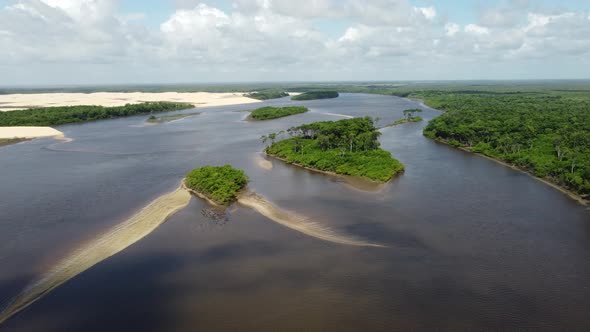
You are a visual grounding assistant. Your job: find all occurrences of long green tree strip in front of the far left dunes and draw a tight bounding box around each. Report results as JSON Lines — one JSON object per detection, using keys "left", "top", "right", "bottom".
{"left": 0, "top": 102, "right": 194, "bottom": 126}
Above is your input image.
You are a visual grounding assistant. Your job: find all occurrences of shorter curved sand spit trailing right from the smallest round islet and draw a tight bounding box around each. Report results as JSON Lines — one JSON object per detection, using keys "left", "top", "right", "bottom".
{"left": 238, "top": 192, "right": 384, "bottom": 247}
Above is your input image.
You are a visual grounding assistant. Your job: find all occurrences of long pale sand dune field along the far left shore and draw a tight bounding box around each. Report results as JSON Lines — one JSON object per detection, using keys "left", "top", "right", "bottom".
{"left": 0, "top": 92, "right": 259, "bottom": 111}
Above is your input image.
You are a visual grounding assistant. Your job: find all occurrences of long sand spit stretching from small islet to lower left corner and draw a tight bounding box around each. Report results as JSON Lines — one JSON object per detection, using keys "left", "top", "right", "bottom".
{"left": 0, "top": 188, "right": 191, "bottom": 324}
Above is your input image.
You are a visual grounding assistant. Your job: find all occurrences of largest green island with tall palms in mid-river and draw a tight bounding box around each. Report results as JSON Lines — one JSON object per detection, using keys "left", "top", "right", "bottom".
{"left": 262, "top": 117, "right": 404, "bottom": 182}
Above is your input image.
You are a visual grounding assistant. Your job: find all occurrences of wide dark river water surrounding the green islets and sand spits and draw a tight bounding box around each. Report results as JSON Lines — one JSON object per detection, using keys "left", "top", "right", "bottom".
{"left": 0, "top": 94, "right": 590, "bottom": 331}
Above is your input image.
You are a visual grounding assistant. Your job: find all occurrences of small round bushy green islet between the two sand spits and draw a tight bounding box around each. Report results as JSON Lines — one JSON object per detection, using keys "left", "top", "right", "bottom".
{"left": 184, "top": 165, "right": 250, "bottom": 204}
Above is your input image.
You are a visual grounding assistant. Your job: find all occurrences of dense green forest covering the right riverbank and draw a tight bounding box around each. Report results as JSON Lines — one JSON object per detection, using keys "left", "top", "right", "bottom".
{"left": 422, "top": 91, "right": 590, "bottom": 196}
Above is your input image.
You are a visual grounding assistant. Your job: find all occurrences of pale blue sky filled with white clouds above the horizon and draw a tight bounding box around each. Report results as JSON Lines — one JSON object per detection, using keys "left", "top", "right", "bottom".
{"left": 0, "top": 0, "right": 590, "bottom": 86}
